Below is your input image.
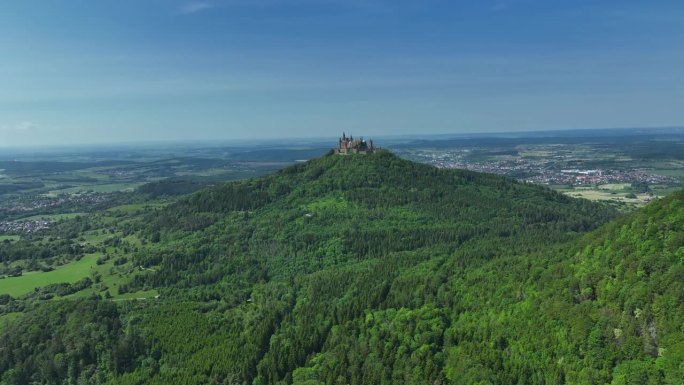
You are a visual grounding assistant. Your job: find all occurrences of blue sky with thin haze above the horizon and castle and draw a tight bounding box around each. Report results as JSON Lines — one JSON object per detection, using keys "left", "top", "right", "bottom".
{"left": 0, "top": 0, "right": 684, "bottom": 147}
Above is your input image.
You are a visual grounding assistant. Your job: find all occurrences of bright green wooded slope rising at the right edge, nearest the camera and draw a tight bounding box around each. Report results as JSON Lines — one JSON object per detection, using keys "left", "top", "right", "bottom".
{"left": 535, "top": 190, "right": 684, "bottom": 384}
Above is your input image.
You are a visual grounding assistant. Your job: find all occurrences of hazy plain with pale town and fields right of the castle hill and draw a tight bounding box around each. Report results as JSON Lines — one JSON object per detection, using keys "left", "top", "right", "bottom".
{"left": 393, "top": 138, "right": 684, "bottom": 211}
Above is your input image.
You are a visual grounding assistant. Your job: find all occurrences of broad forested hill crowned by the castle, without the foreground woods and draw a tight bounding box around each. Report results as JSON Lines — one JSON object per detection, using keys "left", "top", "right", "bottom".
{"left": 139, "top": 151, "right": 615, "bottom": 292}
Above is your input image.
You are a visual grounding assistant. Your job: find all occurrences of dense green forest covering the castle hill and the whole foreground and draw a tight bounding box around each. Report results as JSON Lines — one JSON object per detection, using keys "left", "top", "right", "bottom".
{"left": 0, "top": 151, "right": 684, "bottom": 385}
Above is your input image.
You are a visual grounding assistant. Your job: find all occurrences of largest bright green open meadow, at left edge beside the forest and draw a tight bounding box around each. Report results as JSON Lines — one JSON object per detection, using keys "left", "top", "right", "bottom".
{"left": 0, "top": 253, "right": 102, "bottom": 297}
